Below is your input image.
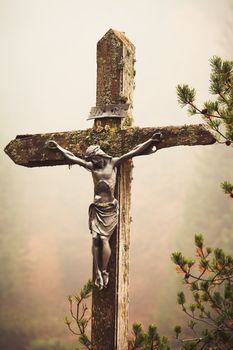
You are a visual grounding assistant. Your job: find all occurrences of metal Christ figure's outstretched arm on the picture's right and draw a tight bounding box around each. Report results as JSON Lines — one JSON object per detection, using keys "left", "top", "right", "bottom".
{"left": 114, "top": 132, "right": 162, "bottom": 166}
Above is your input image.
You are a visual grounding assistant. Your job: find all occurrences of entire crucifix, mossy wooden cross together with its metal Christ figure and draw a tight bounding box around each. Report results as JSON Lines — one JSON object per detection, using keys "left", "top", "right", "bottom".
{"left": 5, "top": 29, "right": 216, "bottom": 350}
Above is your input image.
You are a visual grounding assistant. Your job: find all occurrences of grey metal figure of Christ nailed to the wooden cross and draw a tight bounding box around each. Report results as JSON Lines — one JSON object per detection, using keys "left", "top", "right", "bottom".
{"left": 46, "top": 133, "right": 162, "bottom": 290}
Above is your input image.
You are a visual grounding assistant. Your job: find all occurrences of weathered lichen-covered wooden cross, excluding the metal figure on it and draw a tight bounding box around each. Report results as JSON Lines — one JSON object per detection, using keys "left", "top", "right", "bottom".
{"left": 5, "top": 29, "right": 216, "bottom": 350}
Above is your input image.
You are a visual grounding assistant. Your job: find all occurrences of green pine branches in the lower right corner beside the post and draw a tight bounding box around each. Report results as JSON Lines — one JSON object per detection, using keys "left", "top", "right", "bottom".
{"left": 171, "top": 234, "right": 233, "bottom": 350}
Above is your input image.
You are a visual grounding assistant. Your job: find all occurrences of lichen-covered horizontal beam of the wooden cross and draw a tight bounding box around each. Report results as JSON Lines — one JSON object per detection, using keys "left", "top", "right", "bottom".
{"left": 5, "top": 124, "right": 216, "bottom": 167}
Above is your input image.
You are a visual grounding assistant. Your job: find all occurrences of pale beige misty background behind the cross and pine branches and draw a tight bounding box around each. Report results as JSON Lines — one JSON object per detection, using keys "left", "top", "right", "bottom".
{"left": 0, "top": 0, "right": 233, "bottom": 350}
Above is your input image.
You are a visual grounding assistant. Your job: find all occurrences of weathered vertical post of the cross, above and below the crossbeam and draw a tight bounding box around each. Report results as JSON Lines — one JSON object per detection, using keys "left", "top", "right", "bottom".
{"left": 92, "top": 29, "right": 135, "bottom": 350}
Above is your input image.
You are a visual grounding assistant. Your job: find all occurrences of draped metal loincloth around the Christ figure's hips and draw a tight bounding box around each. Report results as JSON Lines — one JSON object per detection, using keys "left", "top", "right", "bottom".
{"left": 89, "top": 199, "right": 118, "bottom": 238}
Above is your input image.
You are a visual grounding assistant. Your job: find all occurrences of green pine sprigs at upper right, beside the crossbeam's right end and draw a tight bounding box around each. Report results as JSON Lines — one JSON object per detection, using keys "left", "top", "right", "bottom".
{"left": 177, "top": 56, "right": 233, "bottom": 198}
